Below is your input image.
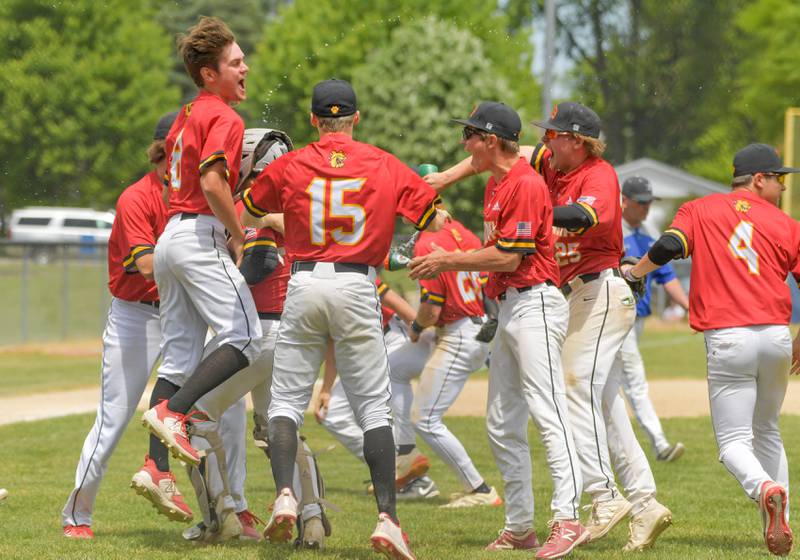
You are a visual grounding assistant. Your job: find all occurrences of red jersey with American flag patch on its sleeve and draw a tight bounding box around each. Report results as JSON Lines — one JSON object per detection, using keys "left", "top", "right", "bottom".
{"left": 481, "top": 158, "right": 558, "bottom": 300}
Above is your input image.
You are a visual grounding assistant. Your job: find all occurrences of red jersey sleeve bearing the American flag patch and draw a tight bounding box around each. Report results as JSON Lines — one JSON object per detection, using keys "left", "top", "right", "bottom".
{"left": 494, "top": 175, "right": 546, "bottom": 254}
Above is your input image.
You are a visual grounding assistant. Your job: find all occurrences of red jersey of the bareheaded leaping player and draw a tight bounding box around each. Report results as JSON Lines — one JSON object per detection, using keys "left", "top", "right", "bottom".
{"left": 166, "top": 91, "right": 244, "bottom": 216}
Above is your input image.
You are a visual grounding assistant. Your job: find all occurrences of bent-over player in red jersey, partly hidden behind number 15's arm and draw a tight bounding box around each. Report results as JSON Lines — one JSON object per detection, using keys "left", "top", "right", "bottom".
{"left": 390, "top": 220, "right": 503, "bottom": 508}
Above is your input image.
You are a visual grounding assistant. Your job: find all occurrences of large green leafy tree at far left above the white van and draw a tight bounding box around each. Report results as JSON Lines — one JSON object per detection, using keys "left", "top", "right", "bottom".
{"left": 0, "top": 0, "right": 178, "bottom": 211}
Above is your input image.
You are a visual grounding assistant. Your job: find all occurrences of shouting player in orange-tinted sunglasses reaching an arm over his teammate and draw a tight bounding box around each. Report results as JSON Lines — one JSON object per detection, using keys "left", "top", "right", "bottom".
{"left": 426, "top": 102, "right": 672, "bottom": 551}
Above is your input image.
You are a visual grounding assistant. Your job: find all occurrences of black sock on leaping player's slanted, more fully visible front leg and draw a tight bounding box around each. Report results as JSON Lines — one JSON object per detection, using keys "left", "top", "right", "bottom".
{"left": 167, "top": 344, "right": 249, "bottom": 414}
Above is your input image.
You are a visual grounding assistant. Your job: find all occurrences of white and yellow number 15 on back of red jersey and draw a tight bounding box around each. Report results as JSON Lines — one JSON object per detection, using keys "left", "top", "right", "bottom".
{"left": 306, "top": 177, "right": 367, "bottom": 245}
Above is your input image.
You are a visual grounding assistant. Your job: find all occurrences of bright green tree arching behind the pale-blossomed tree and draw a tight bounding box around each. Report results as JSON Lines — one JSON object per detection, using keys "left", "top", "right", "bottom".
{"left": 243, "top": 0, "right": 539, "bottom": 144}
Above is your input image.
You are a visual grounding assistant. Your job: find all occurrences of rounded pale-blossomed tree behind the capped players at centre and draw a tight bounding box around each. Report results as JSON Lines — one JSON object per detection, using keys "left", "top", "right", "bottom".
{"left": 353, "top": 18, "right": 516, "bottom": 231}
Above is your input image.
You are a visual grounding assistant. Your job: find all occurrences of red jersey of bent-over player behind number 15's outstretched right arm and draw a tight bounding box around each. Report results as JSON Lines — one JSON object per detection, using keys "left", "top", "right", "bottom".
{"left": 414, "top": 220, "right": 483, "bottom": 326}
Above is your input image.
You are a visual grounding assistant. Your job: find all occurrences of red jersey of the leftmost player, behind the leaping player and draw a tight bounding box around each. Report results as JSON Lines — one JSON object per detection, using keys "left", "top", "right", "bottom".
{"left": 108, "top": 171, "right": 167, "bottom": 301}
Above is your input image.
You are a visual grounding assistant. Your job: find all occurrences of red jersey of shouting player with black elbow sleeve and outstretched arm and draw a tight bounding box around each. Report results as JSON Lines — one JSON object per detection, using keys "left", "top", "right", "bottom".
{"left": 532, "top": 146, "right": 625, "bottom": 285}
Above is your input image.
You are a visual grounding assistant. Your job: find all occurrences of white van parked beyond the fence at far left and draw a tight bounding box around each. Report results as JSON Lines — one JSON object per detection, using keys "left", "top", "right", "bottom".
{"left": 8, "top": 206, "right": 114, "bottom": 244}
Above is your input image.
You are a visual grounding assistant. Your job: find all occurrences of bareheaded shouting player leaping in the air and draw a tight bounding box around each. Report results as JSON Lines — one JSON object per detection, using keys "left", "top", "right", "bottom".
{"left": 136, "top": 18, "right": 262, "bottom": 469}
